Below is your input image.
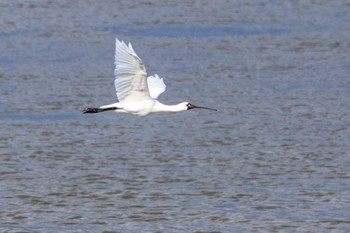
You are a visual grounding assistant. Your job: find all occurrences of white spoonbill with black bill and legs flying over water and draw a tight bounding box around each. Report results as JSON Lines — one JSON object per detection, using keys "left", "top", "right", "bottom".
{"left": 83, "top": 38, "right": 217, "bottom": 116}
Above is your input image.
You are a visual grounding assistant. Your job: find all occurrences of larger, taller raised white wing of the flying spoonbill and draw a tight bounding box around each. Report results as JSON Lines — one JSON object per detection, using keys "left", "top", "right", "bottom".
{"left": 114, "top": 38, "right": 151, "bottom": 102}
